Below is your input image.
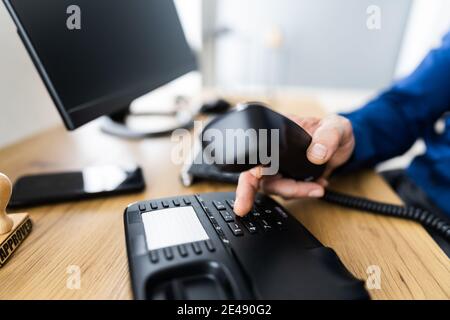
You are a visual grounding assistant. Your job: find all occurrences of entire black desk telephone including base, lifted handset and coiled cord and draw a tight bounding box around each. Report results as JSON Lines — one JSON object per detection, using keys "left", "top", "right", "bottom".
{"left": 124, "top": 103, "right": 450, "bottom": 299}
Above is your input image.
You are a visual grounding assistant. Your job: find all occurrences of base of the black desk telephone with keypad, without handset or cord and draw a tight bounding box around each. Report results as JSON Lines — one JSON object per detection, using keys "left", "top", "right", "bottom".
{"left": 124, "top": 193, "right": 369, "bottom": 300}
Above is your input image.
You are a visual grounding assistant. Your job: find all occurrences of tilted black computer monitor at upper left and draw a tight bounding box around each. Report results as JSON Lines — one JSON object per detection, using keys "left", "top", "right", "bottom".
{"left": 5, "top": 0, "right": 195, "bottom": 129}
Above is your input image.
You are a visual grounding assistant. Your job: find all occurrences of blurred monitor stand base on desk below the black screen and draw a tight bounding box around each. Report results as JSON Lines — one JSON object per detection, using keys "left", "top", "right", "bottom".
{"left": 101, "top": 106, "right": 194, "bottom": 139}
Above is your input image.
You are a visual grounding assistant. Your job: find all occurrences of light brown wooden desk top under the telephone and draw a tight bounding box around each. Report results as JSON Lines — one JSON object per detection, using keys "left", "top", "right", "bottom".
{"left": 0, "top": 97, "right": 450, "bottom": 299}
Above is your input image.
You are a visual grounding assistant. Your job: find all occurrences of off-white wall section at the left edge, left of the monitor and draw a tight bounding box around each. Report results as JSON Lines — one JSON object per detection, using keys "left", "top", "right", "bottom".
{"left": 0, "top": 3, "right": 60, "bottom": 147}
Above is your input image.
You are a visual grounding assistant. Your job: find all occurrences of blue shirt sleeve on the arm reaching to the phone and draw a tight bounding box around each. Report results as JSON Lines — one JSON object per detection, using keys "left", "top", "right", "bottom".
{"left": 340, "top": 32, "right": 450, "bottom": 171}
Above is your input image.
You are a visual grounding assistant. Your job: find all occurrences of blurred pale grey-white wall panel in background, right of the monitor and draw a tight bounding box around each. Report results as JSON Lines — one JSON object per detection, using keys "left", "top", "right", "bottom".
{"left": 210, "top": 0, "right": 411, "bottom": 89}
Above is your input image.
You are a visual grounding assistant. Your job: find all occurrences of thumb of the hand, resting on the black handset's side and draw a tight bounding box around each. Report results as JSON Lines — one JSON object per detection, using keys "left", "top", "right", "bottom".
{"left": 307, "top": 116, "right": 344, "bottom": 165}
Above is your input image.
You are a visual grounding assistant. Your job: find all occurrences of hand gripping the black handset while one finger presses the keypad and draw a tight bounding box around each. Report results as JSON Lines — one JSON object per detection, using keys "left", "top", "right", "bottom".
{"left": 234, "top": 115, "right": 355, "bottom": 216}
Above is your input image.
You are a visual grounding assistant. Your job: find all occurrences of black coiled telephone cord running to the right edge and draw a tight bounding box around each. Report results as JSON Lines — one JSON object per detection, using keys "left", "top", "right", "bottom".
{"left": 323, "top": 190, "right": 450, "bottom": 241}
